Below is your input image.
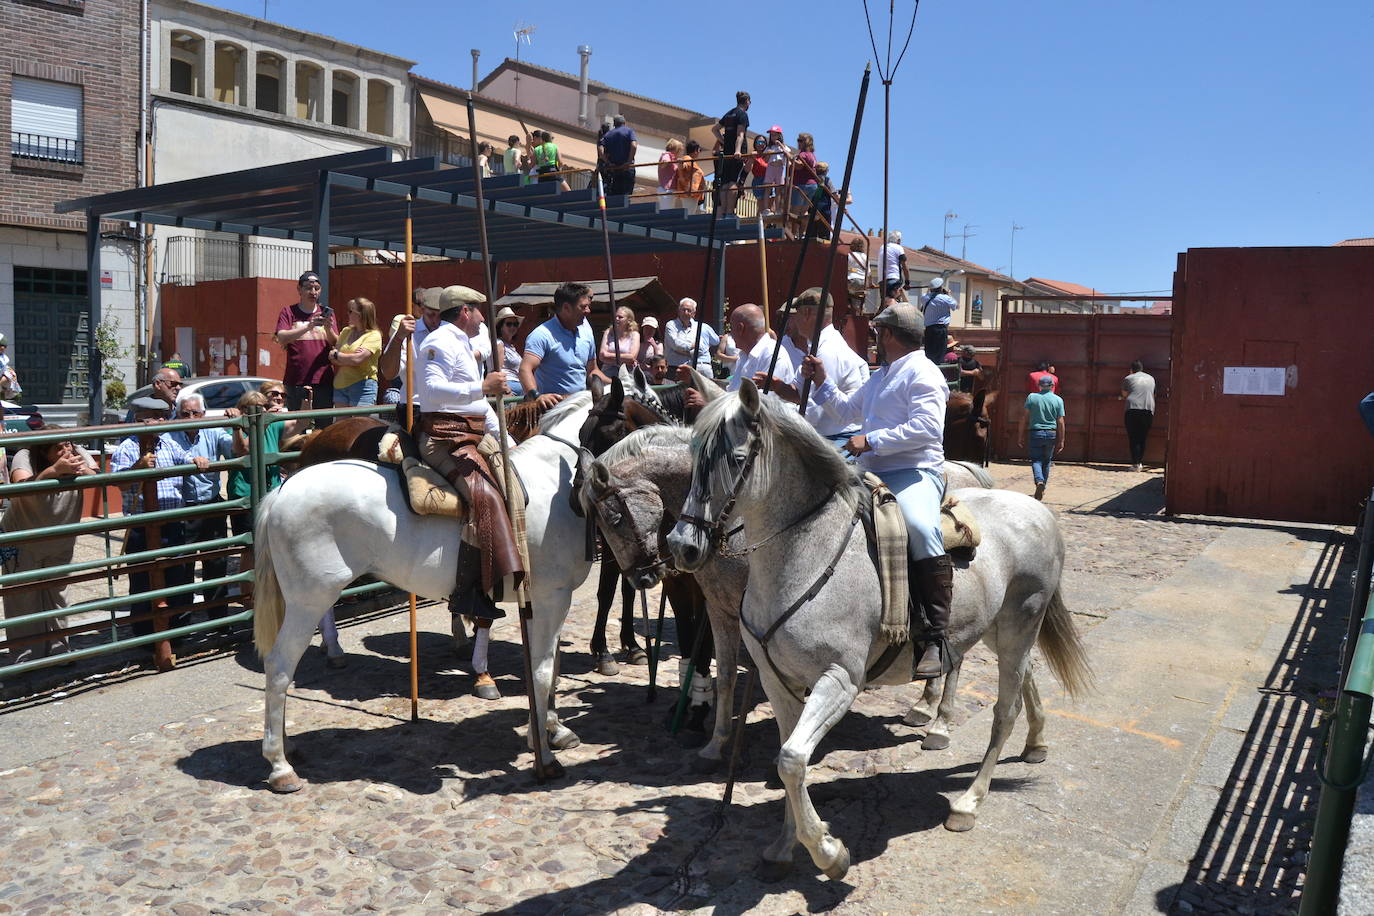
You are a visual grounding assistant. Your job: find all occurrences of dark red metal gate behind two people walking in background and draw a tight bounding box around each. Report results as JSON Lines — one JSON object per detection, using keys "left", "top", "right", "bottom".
{"left": 993, "top": 312, "right": 1172, "bottom": 466}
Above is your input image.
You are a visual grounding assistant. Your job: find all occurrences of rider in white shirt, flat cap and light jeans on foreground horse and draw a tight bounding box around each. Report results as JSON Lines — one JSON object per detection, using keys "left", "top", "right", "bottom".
{"left": 801, "top": 302, "right": 954, "bottom": 680}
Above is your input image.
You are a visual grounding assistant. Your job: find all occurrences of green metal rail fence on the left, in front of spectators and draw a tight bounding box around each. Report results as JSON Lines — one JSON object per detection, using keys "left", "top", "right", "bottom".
{"left": 0, "top": 404, "right": 396, "bottom": 676}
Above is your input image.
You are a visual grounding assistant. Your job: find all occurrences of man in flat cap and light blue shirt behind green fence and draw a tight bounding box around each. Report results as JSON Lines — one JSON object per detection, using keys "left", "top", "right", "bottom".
{"left": 110, "top": 397, "right": 203, "bottom": 636}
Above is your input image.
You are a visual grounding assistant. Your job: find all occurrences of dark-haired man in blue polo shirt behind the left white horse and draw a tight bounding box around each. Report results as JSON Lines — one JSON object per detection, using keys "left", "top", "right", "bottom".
{"left": 519, "top": 283, "right": 610, "bottom": 409}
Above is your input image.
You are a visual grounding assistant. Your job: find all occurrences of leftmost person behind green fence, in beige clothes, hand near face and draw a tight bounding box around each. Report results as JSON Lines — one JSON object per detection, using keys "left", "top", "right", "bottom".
{"left": 0, "top": 426, "right": 96, "bottom": 665}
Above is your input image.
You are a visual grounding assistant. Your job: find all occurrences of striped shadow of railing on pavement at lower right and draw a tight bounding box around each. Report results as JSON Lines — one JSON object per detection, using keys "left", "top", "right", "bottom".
{"left": 1156, "top": 531, "right": 1356, "bottom": 913}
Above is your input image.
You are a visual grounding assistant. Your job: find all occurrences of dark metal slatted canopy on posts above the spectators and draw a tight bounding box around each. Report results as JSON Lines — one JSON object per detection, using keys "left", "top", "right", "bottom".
{"left": 56, "top": 147, "right": 782, "bottom": 422}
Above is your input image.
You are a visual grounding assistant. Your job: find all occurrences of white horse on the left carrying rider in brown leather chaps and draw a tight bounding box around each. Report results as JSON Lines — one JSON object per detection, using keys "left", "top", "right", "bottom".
{"left": 253, "top": 391, "right": 591, "bottom": 792}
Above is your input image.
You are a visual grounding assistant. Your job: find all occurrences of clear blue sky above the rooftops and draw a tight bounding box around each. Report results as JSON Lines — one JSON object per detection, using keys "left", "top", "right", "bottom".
{"left": 230, "top": 0, "right": 1374, "bottom": 293}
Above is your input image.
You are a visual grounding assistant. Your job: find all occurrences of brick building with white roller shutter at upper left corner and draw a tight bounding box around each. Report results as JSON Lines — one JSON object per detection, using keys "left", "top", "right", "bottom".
{"left": 0, "top": 0, "right": 142, "bottom": 404}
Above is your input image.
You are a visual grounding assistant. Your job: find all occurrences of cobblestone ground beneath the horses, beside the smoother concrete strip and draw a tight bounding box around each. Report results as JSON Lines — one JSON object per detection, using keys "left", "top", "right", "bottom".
{"left": 0, "top": 466, "right": 1341, "bottom": 916}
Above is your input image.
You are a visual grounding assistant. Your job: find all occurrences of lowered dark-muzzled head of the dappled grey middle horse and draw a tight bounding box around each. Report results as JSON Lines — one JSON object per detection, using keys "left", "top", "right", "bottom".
{"left": 581, "top": 461, "right": 666, "bottom": 589}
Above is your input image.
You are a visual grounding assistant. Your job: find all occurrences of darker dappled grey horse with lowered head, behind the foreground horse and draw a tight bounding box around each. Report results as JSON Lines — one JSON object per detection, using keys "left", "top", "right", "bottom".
{"left": 580, "top": 426, "right": 993, "bottom": 772}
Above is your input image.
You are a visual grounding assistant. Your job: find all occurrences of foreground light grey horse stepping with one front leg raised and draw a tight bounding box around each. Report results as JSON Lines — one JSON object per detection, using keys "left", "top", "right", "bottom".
{"left": 668, "top": 382, "right": 1091, "bottom": 879}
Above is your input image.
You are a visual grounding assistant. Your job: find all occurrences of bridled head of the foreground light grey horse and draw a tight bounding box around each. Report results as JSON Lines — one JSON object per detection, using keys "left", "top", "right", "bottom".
{"left": 668, "top": 379, "right": 763, "bottom": 573}
